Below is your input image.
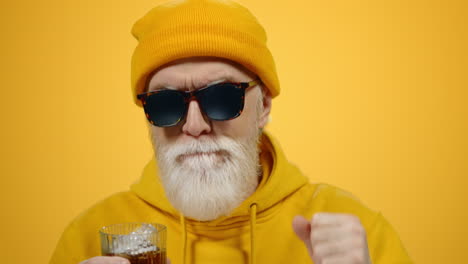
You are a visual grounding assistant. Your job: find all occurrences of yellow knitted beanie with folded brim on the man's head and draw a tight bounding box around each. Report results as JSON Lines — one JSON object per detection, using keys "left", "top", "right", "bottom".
{"left": 131, "top": 0, "right": 280, "bottom": 106}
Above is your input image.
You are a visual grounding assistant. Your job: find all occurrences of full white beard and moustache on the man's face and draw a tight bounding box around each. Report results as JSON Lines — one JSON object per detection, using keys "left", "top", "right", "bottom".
{"left": 153, "top": 131, "right": 261, "bottom": 221}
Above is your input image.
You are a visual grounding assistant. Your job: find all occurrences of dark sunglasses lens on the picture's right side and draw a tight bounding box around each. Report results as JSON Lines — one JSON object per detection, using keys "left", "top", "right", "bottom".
{"left": 197, "top": 83, "right": 244, "bottom": 121}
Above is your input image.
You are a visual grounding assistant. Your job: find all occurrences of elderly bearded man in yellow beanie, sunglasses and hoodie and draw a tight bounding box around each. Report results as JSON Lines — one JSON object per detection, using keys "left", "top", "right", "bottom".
{"left": 51, "top": 0, "right": 411, "bottom": 264}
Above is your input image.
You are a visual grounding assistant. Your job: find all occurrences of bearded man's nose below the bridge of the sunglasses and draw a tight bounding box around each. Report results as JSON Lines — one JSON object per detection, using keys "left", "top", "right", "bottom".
{"left": 182, "top": 100, "right": 211, "bottom": 137}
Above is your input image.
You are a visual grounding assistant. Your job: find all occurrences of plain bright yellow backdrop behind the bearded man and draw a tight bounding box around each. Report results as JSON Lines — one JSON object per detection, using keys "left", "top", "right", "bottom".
{"left": 0, "top": 0, "right": 468, "bottom": 263}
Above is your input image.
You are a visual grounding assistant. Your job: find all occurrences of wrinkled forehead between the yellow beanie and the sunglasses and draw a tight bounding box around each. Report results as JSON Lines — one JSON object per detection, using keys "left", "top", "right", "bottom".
{"left": 145, "top": 57, "right": 256, "bottom": 91}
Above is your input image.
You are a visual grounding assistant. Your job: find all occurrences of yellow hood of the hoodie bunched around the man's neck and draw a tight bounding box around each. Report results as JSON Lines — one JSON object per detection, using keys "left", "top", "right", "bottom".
{"left": 131, "top": 131, "right": 308, "bottom": 225}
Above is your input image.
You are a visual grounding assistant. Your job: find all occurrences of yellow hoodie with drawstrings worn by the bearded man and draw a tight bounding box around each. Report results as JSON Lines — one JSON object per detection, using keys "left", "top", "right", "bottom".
{"left": 50, "top": 132, "right": 412, "bottom": 264}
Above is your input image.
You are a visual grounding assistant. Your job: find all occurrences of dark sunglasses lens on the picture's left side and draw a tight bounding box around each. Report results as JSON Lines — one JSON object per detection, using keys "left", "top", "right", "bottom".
{"left": 145, "top": 90, "right": 185, "bottom": 127}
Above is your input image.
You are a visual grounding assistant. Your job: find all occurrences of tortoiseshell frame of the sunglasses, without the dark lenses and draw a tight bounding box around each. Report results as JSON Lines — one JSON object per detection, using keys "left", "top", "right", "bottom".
{"left": 137, "top": 78, "right": 261, "bottom": 127}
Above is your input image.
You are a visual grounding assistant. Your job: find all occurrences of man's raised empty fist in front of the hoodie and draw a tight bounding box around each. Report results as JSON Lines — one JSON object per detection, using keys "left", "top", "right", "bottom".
{"left": 292, "top": 213, "right": 371, "bottom": 264}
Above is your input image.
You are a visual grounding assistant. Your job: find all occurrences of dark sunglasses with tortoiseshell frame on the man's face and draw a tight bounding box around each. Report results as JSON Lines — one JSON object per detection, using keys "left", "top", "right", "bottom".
{"left": 137, "top": 79, "right": 260, "bottom": 127}
